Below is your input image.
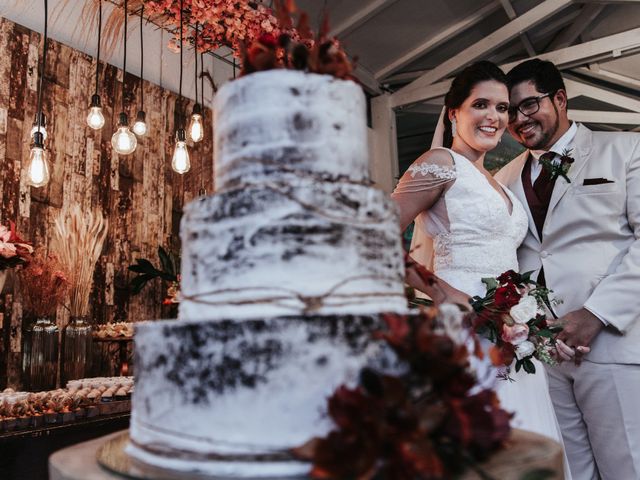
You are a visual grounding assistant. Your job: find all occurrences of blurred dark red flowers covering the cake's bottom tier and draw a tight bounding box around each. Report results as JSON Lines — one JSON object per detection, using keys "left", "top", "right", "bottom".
{"left": 294, "top": 307, "right": 510, "bottom": 480}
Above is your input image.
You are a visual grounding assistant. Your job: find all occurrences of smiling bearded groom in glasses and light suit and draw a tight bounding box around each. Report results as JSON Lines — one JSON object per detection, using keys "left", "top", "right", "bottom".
{"left": 496, "top": 59, "right": 640, "bottom": 480}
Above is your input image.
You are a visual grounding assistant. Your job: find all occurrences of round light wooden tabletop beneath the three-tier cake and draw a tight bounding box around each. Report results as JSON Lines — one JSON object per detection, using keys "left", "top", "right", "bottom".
{"left": 49, "top": 430, "right": 564, "bottom": 480}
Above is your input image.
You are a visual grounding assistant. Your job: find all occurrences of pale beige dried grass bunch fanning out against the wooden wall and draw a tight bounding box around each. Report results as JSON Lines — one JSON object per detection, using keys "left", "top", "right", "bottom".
{"left": 52, "top": 205, "right": 109, "bottom": 317}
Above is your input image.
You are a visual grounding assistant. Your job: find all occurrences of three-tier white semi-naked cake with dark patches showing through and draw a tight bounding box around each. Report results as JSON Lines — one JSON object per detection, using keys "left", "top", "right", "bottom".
{"left": 128, "top": 70, "right": 406, "bottom": 477}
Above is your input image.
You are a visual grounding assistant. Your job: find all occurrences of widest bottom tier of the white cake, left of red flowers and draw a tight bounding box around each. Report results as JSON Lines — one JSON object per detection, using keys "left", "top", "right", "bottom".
{"left": 127, "top": 315, "right": 389, "bottom": 477}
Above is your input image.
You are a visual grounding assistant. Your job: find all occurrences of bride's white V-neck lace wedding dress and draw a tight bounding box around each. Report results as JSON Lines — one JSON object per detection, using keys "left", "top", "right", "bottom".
{"left": 396, "top": 149, "right": 569, "bottom": 478}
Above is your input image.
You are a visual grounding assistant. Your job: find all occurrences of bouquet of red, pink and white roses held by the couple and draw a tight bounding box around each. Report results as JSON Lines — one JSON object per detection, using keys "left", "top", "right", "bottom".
{"left": 471, "top": 270, "right": 562, "bottom": 378}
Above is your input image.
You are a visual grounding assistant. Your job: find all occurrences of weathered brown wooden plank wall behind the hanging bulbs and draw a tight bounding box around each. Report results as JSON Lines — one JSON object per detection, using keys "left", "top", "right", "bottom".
{"left": 0, "top": 18, "right": 213, "bottom": 389}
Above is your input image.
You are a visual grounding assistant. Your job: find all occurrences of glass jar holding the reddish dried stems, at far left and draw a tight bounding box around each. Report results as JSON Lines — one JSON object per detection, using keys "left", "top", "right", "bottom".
{"left": 22, "top": 317, "right": 59, "bottom": 392}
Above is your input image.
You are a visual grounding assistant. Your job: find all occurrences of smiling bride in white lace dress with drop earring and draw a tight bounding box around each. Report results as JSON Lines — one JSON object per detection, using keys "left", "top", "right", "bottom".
{"left": 392, "top": 61, "right": 570, "bottom": 478}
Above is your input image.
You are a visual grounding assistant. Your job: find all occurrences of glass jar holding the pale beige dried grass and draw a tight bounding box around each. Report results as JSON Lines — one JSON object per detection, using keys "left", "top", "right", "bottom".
{"left": 61, "top": 317, "right": 93, "bottom": 385}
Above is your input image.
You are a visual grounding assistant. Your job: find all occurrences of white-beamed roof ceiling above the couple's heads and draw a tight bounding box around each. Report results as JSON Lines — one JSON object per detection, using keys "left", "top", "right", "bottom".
{"left": 297, "top": 0, "right": 640, "bottom": 164}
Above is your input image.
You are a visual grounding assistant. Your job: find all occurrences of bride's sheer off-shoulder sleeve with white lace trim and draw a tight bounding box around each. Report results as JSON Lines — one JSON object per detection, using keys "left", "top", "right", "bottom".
{"left": 393, "top": 151, "right": 457, "bottom": 194}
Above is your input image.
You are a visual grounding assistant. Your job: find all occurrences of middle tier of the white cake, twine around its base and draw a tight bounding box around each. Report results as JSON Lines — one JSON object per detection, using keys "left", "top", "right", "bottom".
{"left": 180, "top": 179, "right": 406, "bottom": 320}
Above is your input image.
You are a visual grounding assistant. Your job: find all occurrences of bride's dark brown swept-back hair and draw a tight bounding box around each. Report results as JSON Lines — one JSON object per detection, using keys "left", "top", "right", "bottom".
{"left": 442, "top": 60, "right": 507, "bottom": 148}
